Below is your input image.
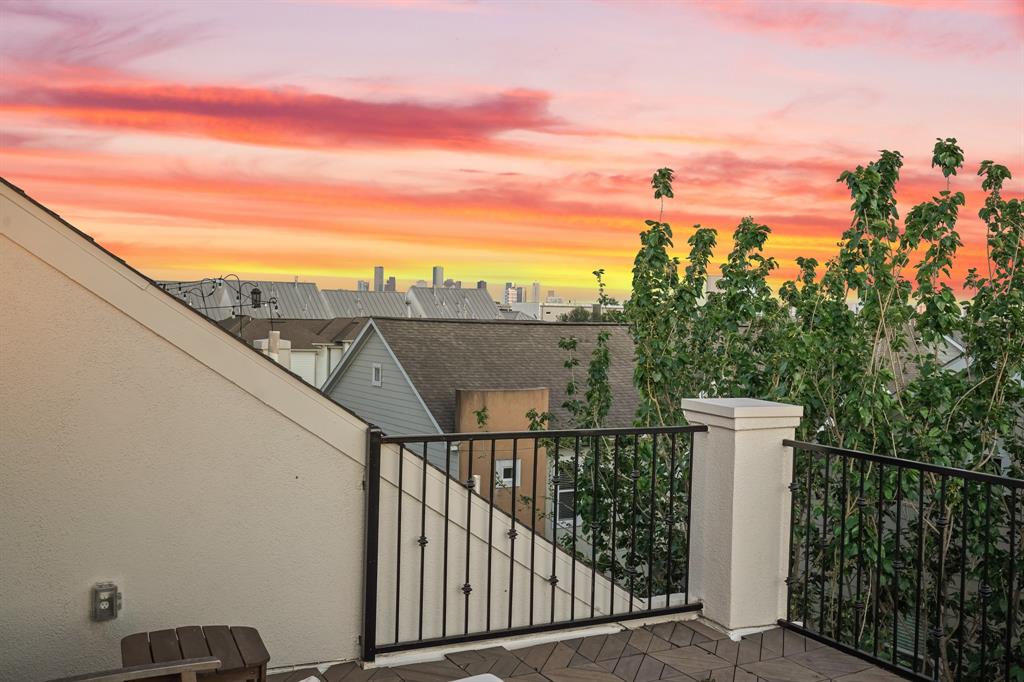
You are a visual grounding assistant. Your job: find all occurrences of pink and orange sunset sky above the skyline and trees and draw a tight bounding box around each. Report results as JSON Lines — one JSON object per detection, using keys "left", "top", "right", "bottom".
{"left": 0, "top": 0, "right": 1024, "bottom": 298}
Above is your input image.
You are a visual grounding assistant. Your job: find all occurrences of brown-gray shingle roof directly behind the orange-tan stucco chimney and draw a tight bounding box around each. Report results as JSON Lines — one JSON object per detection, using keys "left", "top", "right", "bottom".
{"left": 374, "top": 318, "right": 637, "bottom": 432}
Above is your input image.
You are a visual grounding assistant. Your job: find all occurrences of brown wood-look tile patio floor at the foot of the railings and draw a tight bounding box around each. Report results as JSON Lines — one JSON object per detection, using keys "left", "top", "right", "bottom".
{"left": 268, "top": 621, "right": 901, "bottom": 682}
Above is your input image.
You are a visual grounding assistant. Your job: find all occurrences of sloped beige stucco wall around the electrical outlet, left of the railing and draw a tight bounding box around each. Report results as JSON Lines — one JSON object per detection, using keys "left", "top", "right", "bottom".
{"left": 0, "top": 186, "right": 365, "bottom": 681}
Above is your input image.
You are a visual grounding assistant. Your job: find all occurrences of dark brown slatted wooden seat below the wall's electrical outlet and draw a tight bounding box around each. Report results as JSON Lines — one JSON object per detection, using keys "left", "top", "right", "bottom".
{"left": 121, "top": 626, "right": 270, "bottom": 682}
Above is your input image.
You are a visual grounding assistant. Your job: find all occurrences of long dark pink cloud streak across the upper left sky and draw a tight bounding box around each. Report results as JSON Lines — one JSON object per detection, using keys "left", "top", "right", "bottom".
{"left": 0, "top": 82, "right": 558, "bottom": 151}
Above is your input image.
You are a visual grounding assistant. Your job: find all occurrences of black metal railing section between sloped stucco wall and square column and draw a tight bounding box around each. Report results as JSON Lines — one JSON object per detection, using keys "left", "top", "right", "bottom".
{"left": 361, "top": 425, "right": 707, "bottom": 660}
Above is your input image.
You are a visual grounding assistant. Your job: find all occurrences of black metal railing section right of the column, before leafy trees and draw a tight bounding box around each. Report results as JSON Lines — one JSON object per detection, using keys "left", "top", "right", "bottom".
{"left": 780, "top": 440, "right": 1024, "bottom": 681}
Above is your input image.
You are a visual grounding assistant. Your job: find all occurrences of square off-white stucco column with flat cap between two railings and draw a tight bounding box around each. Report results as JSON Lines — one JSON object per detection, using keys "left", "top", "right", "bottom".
{"left": 682, "top": 398, "right": 804, "bottom": 630}
